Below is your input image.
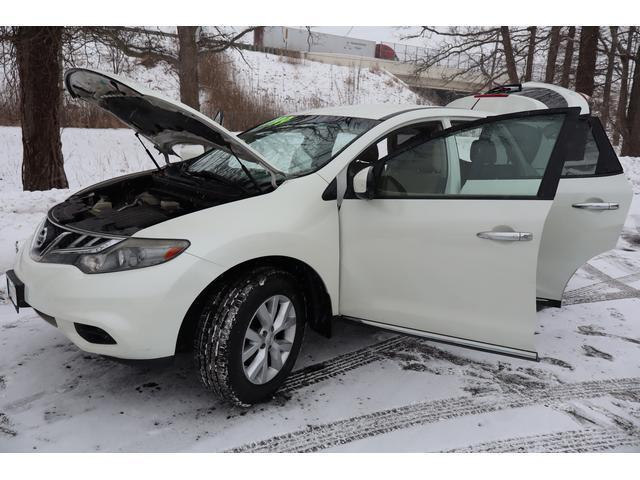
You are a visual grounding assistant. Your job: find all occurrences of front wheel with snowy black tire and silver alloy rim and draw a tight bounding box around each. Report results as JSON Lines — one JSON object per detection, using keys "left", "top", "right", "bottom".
{"left": 194, "top": 267, "right": 306, "bottom": 407}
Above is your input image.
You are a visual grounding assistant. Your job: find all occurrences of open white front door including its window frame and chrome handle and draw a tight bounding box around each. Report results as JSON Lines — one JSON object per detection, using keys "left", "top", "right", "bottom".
{"left": 340, "top": 109, "right": 577, "bottom": 357}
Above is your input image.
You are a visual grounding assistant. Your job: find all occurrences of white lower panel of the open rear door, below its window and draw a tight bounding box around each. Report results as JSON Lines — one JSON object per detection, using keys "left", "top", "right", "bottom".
{"left": 536, "top": 174, "right": 633, "bottom": 301}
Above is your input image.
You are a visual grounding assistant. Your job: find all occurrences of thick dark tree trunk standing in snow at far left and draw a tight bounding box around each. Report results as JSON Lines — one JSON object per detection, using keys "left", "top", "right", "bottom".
{"left": 13, "top": 27, "right": 69, "bottom": 191}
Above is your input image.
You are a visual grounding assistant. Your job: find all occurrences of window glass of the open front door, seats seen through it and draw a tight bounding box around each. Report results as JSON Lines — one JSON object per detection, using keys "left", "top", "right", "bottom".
{"left": 376, "top": 113, "right": 565, "bottom": 198}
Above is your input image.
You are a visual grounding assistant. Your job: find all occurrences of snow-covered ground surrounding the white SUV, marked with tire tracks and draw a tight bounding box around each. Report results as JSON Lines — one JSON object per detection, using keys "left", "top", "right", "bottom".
{"left": 0, "top": 129, "right": 640, "bottom": 452}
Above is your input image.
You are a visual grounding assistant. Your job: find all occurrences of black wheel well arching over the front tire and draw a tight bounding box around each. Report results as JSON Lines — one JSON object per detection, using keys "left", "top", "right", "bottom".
{"left": 176, "top": 256, "right": 333, "bottom": 353}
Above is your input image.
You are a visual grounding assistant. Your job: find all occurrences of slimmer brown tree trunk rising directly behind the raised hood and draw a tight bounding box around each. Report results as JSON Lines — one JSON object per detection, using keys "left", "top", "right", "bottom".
{"left": 178, "top": 27, "right": 200, "bottom": 110}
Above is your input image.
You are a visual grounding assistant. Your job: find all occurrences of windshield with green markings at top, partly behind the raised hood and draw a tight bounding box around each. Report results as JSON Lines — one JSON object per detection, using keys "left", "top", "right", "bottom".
{"left": 187, "top": 115, "right": 379, "bottom": 183}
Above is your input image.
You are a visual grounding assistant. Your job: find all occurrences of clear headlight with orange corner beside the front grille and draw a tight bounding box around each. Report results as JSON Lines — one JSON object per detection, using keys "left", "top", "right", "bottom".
{"left": 42, "top": 238, "right": 190, "bottom": 273}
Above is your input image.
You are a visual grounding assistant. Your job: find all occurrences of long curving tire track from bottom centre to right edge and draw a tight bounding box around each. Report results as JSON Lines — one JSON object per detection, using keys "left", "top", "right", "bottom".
{"left": 229, "top": 378, "right": 640, "bottom": 452}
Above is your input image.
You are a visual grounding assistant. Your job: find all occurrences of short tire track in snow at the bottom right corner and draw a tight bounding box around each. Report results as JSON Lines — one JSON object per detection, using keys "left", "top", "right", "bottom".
{"left": 447, "top": 428, "right": 640, "bottom": 453}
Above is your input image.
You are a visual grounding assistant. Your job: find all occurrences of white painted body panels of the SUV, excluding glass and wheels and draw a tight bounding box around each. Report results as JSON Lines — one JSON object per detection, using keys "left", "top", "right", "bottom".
{"left": 7, "top": 70, "right": 631, "bottom": 368}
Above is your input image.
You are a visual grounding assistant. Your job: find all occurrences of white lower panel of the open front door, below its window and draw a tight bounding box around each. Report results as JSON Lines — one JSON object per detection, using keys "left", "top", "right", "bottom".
{"left": 340, "top": 199, "right": 551, "bottom": 351}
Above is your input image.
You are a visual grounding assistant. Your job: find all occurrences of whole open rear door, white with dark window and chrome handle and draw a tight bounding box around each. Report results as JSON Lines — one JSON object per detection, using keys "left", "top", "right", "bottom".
{"left": 537, "top": 116, "right": 633, "bottom": 302}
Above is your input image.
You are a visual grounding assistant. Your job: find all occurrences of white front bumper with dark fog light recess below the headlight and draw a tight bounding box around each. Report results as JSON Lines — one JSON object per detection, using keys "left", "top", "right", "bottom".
{"left": 15, "top": 242, "right": 224, "bottom": 360}
